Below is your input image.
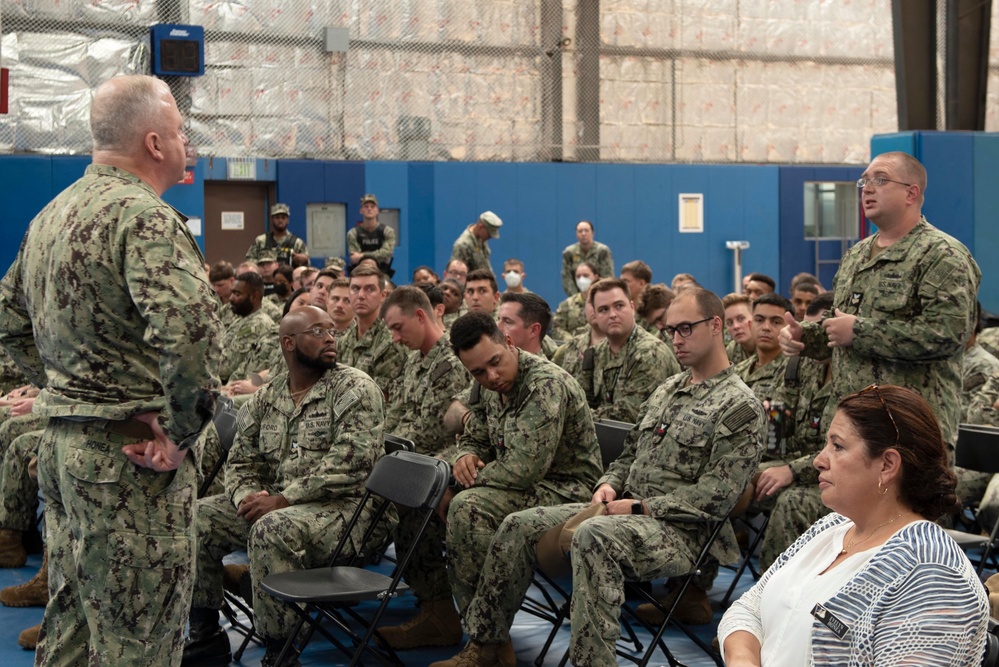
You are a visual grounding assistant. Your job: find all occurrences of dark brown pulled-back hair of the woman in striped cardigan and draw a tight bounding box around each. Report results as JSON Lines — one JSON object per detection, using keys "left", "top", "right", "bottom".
{"left": 838, "top": 385, "right": 961, "bottom": 521}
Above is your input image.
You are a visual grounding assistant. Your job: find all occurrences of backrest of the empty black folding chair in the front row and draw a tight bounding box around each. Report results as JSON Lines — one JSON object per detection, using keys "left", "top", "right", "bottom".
{"left": 365, "top": 451, "right": 451, "bottom": 509}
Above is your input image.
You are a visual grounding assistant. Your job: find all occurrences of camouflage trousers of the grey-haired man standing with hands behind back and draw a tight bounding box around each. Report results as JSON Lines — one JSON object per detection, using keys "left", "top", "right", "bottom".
{"left": 35, "top": 418, "right": 196, "bottom": 665}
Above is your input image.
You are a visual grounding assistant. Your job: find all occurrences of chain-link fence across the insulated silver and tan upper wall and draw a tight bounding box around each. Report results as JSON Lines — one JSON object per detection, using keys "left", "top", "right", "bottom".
{"left": 0, "top": 0, "right": 999, "bottom": 164}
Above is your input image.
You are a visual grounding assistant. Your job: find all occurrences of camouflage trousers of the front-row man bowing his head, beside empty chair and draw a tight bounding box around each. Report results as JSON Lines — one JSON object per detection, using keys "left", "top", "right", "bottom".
{"left": 446, "top": 487, "right": 569, "bottom": 615}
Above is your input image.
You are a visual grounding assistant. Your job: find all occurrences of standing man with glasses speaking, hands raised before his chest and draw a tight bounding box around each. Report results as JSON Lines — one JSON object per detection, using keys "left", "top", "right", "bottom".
{"left": 779, "top": 152, "right": 982, "bottom": 454}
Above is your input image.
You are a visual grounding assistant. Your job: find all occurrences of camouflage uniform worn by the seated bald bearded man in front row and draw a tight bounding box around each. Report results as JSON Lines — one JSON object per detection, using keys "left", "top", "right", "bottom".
{"left": 192, "top": 365, "right": 384, "bottom": 639}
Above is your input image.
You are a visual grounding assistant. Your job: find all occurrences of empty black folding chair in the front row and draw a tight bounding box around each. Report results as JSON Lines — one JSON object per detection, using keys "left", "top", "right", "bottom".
{"left": 261, "top": 451, "right": 451, "bottom": 665}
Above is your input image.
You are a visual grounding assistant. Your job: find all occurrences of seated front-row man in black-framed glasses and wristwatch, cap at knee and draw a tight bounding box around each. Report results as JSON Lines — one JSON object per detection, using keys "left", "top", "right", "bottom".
{"left": 431, "top": 288, "right": 766, "bottom": 667}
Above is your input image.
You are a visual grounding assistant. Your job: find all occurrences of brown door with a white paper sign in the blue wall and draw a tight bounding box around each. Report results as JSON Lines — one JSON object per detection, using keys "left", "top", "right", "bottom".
{"left": 204, "top": 181, "right": 275, "bottom": 268}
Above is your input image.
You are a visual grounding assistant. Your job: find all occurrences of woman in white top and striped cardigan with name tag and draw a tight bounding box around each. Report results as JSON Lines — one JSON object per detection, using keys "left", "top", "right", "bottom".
{"left": 718, "top": 385, "right": 989, "bottom": 667}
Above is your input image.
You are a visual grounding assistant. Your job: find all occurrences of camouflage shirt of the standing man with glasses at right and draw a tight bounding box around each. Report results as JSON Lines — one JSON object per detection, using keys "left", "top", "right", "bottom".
{"left": 802, "top": 218, "right": 981, "bottom": 448}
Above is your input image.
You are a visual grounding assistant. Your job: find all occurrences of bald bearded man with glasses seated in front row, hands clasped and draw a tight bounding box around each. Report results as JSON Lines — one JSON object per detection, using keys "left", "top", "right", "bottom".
{"left": 184, "top": 306, "right": 384, "bottom": 665}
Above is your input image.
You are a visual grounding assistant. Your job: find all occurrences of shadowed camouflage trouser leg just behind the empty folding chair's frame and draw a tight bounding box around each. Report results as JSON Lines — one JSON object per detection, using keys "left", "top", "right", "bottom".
{"left": 395, "top": 507, "right": 451, "bottom": 602}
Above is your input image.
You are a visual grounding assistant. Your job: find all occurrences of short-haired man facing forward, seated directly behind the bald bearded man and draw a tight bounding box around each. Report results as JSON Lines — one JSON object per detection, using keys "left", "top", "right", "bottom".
{"left": 337, "top": 266, "right": 406, "bottom": 403}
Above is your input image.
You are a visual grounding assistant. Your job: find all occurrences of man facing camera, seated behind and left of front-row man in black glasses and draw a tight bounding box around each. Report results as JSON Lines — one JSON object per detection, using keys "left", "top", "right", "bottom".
{"left": 573, "top": 278, "right": 680, "bottom": 422}
